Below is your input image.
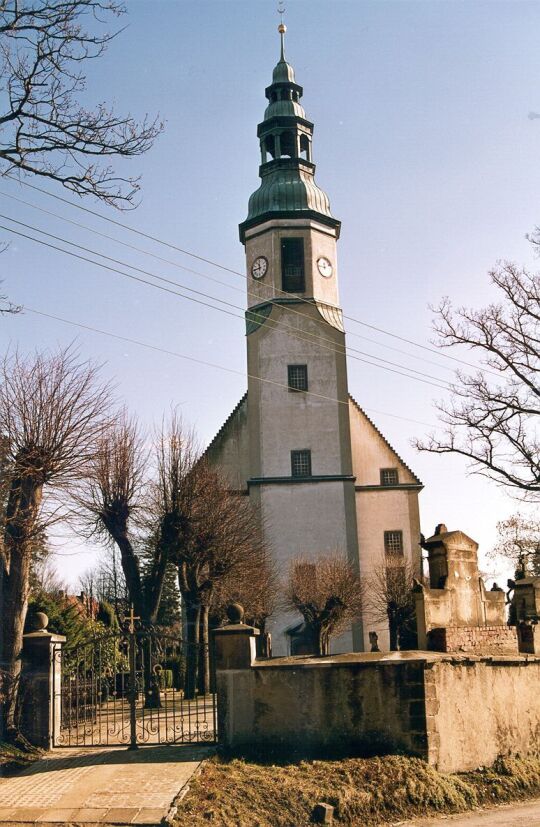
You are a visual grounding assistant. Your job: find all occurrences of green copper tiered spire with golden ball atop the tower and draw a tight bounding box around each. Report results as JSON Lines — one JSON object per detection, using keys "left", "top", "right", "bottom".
{"left": 240, "top": 23, "right": 340, "bottom": 241}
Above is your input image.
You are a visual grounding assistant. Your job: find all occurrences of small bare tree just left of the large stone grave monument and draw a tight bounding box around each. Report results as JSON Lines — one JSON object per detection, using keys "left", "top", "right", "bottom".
{"left": 366, "top": 554, "right": 416, "bottom": 652}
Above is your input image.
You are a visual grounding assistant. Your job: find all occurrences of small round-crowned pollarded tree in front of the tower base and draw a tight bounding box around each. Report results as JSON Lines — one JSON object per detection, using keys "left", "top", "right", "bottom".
{"left": 285, "top": 552, "right": 363, "bottom": 655}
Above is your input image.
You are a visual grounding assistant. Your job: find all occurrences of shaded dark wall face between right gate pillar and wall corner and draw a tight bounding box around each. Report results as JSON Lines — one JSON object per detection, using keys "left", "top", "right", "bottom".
{"left": 217, "top": 654, "right": 427, "bottom": 757}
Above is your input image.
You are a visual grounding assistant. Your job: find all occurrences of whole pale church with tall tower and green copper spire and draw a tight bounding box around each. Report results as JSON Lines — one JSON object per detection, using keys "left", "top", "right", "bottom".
{"left": 205, "top": 23, "right": 422, "bottom": 655}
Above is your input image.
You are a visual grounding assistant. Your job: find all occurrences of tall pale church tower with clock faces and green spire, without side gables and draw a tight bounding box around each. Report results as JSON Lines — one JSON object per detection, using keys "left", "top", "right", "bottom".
{"left": 240, "top": 24, "right": 358, "bottom": 648}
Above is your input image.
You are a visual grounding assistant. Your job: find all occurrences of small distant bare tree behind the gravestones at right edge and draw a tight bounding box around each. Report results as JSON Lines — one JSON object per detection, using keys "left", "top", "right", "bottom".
{"left": 490, "top": 513, "right": 540, "bottom": 580}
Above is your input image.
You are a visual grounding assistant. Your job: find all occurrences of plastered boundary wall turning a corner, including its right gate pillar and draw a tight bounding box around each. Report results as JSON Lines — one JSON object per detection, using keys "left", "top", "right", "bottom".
{"left": 216, "top": 624, "right": 540, "bottom": 772}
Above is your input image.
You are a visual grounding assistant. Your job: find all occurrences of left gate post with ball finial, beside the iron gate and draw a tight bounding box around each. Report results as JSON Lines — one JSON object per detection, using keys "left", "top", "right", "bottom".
{"left": 21, "top": 612, "right": 66, "bottom": 749}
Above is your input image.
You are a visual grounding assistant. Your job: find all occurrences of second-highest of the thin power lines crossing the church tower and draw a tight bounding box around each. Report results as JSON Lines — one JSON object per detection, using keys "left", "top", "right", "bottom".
{"left": 0, "top": 190, "right": 464, "bottom": 371}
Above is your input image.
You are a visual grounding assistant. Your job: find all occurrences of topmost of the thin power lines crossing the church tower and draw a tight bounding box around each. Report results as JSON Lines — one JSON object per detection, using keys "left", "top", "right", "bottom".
{"left": 6, "top": 178, "right": 496, "bottom": 375}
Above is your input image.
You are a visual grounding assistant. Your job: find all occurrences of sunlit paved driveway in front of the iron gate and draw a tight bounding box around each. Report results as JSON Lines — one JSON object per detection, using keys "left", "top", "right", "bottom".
{"left": 0, "top": 745, "right": 213, "bottom": 827}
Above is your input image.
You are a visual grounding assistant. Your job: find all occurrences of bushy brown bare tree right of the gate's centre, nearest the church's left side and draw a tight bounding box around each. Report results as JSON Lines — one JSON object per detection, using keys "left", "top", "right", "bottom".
{"left": 153, "top": 414, "right": 262, "bottom": 698}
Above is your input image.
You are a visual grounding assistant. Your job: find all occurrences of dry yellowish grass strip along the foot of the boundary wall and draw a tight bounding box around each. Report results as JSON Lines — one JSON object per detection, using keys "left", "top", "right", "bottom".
{"left": 175, "top": 755, "right": 540, "bottom": 827}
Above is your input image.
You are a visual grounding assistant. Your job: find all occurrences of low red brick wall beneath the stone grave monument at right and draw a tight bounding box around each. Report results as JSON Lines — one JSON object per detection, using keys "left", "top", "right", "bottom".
{"left": 428, "top": 626, "right": 518, "bottom": 655}
